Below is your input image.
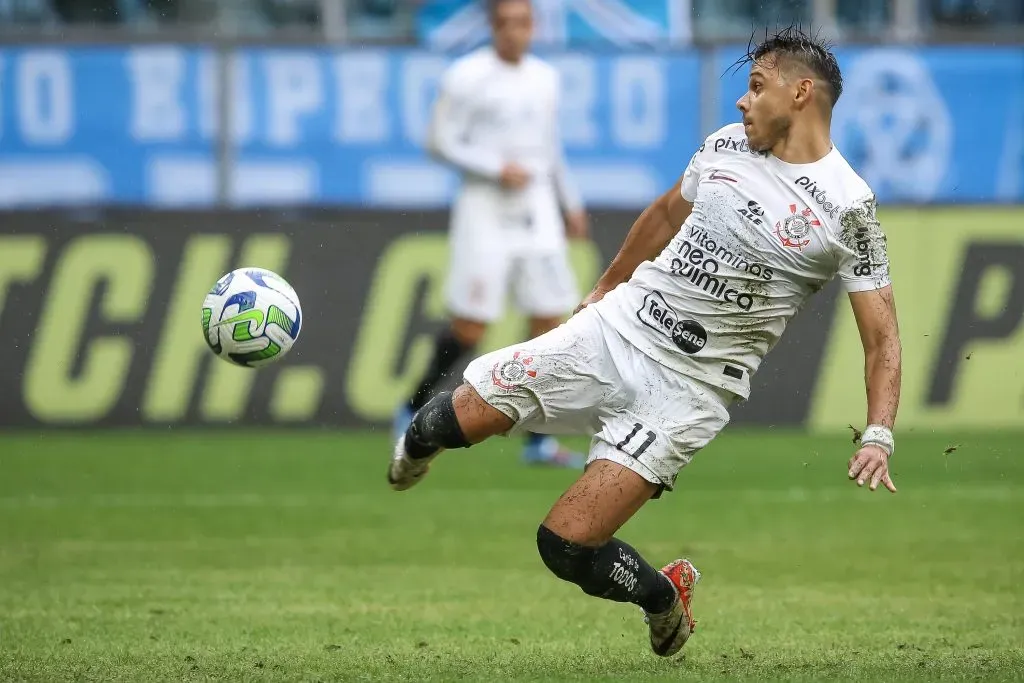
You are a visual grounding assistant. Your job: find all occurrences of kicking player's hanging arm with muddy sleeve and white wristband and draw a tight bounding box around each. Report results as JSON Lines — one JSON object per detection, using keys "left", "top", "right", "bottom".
{"left": 839, "top": 197, "right": 902, "bottom": 493}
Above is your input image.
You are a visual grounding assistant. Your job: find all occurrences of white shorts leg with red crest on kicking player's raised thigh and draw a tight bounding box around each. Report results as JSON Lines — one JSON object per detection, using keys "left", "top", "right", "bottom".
{"left": 464, "top": 309, "right": 615, "bottom": 435}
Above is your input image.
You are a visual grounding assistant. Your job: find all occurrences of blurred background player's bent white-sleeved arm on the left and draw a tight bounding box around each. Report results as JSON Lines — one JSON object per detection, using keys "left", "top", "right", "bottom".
{"left": 426, "top": 63, "right": 527, "bottom": 186}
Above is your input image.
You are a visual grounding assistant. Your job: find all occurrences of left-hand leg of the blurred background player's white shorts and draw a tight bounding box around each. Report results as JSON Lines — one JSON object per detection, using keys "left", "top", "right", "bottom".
{"left": 445, "top": 236, "right": 513, "bottom": 323}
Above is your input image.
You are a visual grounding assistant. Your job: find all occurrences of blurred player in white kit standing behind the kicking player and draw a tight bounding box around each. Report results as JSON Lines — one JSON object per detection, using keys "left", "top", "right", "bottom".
{"left": 394, "top": 0, "right": 588, "bottom": 467}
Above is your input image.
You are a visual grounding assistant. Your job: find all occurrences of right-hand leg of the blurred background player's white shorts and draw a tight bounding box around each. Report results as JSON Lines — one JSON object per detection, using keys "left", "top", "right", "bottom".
{"left": 512, "top": 251, "right": 580, "bottom": 317}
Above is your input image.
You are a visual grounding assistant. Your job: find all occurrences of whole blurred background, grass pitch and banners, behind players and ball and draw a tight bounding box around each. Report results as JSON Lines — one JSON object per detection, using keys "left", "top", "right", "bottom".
{"left": 0, "top": 5, "right": 1024, "bottom": 683}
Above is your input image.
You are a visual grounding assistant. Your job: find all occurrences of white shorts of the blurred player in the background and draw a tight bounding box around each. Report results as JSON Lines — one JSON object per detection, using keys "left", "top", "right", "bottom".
{"left": 446, "top": 243, "right": 580, "bottom": 323}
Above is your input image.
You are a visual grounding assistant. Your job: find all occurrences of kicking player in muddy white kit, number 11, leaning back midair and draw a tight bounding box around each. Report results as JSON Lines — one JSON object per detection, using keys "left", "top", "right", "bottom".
{"left": 388, "top": 29, "right": 901, "bottom": 655}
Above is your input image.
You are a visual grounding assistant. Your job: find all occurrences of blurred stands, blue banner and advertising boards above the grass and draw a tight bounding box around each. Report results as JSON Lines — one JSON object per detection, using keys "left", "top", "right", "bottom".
{"left": 0, "top": 0, "right": 1024, "bottom": 429}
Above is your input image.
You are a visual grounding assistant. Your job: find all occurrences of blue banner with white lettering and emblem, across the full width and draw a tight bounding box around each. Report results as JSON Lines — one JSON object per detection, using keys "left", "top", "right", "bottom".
{"left": 0, "top": 45, "right": 1024, "bottom": 208}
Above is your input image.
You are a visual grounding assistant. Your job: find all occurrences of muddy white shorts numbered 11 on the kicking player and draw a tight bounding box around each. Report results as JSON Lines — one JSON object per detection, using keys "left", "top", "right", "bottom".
{"left": 463, "top": 308, "right": 733, "bottom": 490}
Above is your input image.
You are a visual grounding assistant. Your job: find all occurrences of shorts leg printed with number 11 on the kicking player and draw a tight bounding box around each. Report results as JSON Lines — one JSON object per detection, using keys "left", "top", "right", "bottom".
{"left": 588, "top": 356, "right": 729, "bottom": 490}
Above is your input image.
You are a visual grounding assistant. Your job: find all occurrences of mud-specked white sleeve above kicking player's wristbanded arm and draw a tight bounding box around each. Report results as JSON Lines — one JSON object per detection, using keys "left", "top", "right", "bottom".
{"left": 839, "top": 196, "right": 892, "bottom": 292}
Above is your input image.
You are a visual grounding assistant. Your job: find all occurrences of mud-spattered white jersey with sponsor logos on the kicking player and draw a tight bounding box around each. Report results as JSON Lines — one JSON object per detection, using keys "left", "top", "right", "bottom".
{"left": 595, "top": 124, "right": 890, "bottom": 398}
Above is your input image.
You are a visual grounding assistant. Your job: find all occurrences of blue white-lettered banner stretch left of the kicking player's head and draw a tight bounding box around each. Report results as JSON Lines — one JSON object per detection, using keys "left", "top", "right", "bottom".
{"left": 0, "top": 46, "right": 700, "bottom": 207}
